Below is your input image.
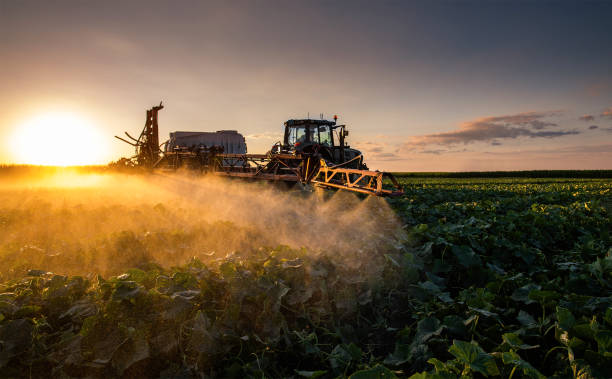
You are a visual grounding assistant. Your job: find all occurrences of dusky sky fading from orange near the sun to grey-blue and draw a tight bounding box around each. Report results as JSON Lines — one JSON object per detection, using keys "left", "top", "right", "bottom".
{"left": 0, "top": 0, "right": 612, "bottom": 171}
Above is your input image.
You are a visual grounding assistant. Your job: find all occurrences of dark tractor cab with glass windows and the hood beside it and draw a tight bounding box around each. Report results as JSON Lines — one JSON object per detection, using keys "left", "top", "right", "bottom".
{"left": 281, "top": 116, "right": 366, "bottom": 169}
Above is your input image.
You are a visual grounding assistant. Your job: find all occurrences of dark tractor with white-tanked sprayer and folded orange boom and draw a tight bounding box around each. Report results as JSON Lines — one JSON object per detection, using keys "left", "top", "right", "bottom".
{"left": 115, "top": 103, "right": 403, "bottom": 196}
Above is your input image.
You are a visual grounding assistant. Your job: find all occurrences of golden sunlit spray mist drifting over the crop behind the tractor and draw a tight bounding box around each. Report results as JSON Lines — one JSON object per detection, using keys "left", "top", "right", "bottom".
{"left": 0, "top": 168, "right": 408, "bottom": 280}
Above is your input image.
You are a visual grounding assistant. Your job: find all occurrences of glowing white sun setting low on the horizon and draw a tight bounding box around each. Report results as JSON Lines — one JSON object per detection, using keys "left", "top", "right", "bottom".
{"left": 10, "top": 113, "right": 106, "bottom": 166}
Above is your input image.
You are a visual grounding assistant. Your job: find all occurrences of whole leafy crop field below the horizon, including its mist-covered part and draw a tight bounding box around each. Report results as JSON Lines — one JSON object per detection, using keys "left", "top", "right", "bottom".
{"left": 0, "top": 177, "right": 612, "bottom": 378}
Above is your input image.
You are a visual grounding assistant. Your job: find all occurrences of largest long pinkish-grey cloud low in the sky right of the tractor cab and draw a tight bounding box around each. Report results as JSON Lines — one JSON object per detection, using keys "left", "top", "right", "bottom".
{"left": 406, "top": 111, "right": 580, "bottom": 147}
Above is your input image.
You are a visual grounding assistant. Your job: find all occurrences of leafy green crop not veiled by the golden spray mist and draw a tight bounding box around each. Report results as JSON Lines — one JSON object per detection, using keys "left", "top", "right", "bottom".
{"left": 0, "top": 177, "right": 612, "bottom": 378}
